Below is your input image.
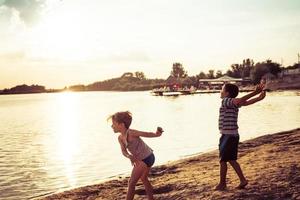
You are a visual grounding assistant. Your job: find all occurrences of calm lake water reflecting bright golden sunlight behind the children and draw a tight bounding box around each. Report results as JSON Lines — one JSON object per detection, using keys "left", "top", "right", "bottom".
{"left": 0, "top": 91, "right": 300, "bottom": 200}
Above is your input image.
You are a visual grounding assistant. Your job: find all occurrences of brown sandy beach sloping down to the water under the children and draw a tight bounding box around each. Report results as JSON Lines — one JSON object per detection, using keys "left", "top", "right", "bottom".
{"left": 44, "top": 128, "right": 300, "bottom": 200}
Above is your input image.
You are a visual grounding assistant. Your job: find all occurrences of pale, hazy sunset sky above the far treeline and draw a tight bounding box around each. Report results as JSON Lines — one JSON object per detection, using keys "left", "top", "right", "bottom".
{"left": 0, "top": 0, "right": 300, "bottom": 89}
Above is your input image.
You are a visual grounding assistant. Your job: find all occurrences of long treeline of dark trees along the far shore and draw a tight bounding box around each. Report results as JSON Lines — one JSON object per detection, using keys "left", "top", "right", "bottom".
{"left": 0, "top": 58, "right": 300, "bottom": 94}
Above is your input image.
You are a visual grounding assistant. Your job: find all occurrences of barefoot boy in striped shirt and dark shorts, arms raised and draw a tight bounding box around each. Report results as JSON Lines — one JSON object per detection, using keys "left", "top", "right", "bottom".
{"left": 216, "top": 83, "right": 266, "bottom": 190}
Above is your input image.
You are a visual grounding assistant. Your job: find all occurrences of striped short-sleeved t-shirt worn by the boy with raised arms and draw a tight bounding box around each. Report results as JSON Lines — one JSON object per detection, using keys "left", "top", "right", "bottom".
{"left": 219, "top": 97, "right": 239, "bottom": 134}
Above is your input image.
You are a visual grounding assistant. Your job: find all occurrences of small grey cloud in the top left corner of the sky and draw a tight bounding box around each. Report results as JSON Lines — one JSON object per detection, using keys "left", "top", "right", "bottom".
{"left": 0, "top": 0, "right": 46, "bottom": 25}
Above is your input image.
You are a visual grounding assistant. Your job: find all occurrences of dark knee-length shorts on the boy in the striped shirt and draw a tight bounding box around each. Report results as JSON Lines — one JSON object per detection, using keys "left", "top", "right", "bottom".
{"left": 219, "top": 134, "right": 240, "bottom": 162}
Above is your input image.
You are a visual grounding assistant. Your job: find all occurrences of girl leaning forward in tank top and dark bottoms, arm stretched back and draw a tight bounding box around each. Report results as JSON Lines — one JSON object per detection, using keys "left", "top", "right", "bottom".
{"left": 109, "top": 111, "right": 163, "bottom": 200}
